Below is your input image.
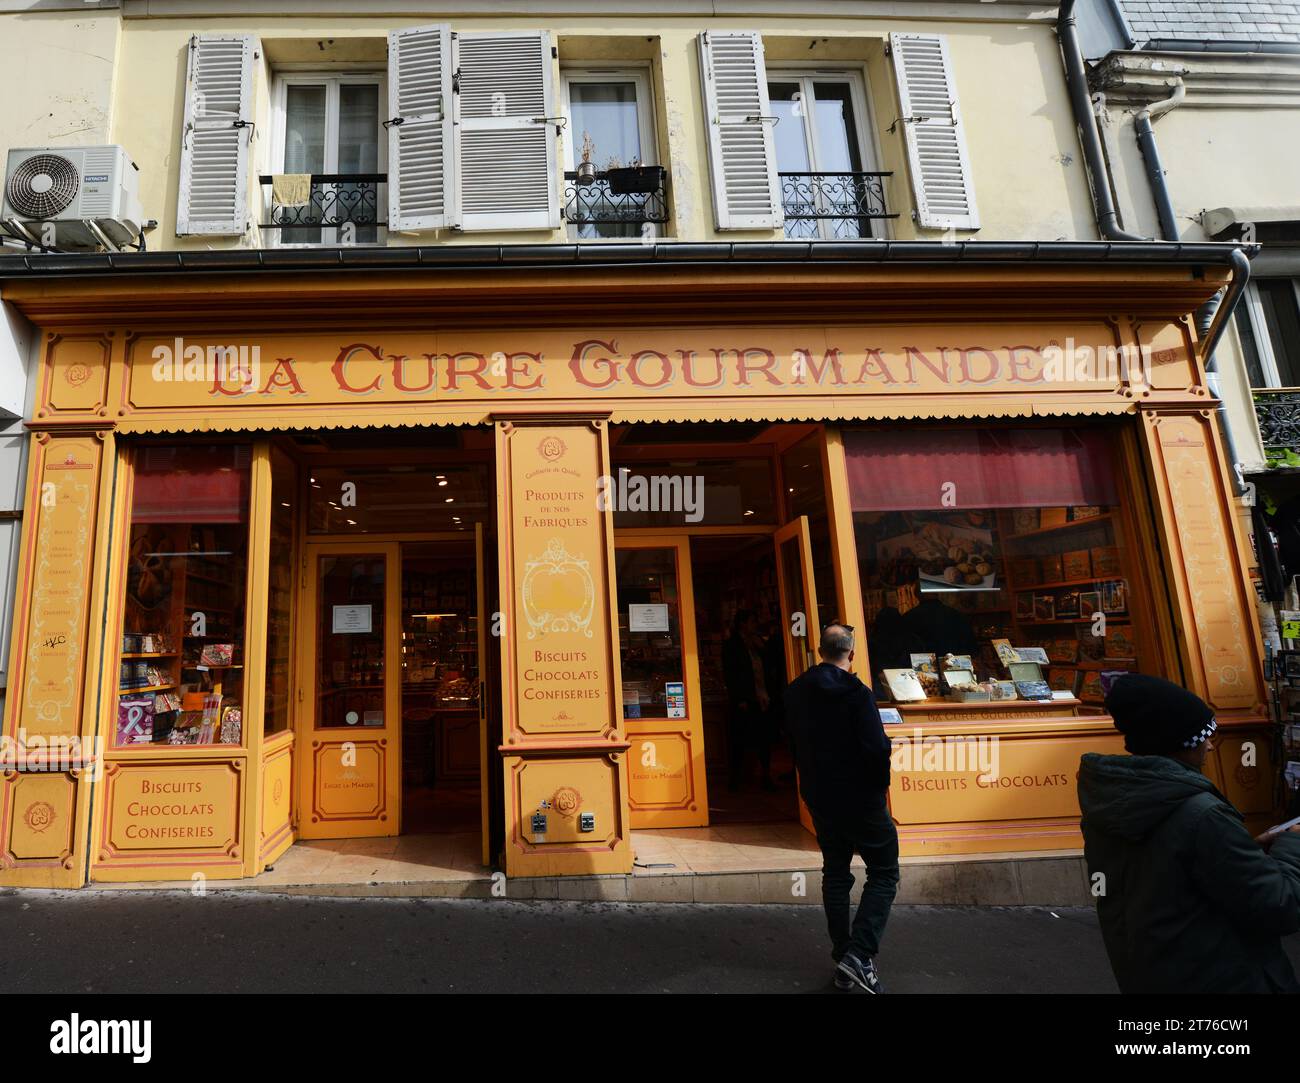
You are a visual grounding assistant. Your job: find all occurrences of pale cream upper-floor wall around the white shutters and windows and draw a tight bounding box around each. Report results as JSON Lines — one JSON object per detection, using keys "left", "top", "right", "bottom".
{"left": 96, "top": 16, "right": 1096, "bottom": 248}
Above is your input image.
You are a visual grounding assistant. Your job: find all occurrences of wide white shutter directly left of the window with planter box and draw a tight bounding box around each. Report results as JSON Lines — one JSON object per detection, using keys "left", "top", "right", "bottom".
{"left": 452, "top": 31, "right": 560, "bottom": 230}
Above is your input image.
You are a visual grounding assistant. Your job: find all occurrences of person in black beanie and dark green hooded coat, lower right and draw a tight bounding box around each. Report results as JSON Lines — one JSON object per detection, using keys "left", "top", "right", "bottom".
{"left": 1079, "top": 673, "right": 1300, "bottom": 993}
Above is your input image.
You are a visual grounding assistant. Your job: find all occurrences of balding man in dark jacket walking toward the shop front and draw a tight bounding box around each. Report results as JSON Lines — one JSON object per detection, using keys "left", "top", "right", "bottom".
{"left": 785, "top": 624, "right": 898, "bottom": 993}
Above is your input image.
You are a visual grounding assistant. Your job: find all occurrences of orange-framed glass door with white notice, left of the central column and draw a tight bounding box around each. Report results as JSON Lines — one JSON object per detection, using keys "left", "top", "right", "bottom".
{"left": 298, "top": 542, "right": 402, "bottom": 839}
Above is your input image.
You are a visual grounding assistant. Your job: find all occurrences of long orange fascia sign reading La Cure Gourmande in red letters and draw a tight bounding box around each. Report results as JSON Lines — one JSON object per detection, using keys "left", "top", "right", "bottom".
{"left": 116, "top": 321, "right": 1164, "bottom": 410}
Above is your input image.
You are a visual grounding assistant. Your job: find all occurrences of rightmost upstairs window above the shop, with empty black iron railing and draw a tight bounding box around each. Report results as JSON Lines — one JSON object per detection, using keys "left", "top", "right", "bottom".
{"left": 767, "top": 70, "right": 884, "bottom": 241}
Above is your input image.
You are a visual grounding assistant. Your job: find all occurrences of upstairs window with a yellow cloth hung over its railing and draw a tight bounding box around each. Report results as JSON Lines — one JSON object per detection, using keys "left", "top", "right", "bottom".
{"left": 267, "top": 73, "right": 387, "bottom": 244}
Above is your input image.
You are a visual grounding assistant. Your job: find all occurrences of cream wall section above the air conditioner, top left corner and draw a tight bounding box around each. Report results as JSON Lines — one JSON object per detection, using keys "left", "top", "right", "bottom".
{"left": 0, "top": 10, "right": 121, "bottom": 161}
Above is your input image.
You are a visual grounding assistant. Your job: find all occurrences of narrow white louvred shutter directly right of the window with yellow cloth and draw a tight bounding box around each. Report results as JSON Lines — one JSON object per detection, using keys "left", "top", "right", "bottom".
{"left": 386, "top": 23, "right": 458, "bottom": 230}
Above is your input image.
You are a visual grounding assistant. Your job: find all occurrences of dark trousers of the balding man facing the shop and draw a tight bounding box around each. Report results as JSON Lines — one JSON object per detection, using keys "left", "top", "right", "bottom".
{"left": 813, "top": 809, "right": 898, "bottom": 962}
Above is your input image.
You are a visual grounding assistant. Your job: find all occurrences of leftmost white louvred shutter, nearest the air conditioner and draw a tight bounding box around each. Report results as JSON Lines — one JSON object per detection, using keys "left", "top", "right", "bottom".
{"left": 176, "top": 34, "right": 257, "bottom": 237}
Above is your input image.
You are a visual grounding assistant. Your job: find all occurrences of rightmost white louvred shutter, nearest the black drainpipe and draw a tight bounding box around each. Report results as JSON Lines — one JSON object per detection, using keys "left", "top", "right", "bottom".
{"left": 889, "top": 34, "right": 979, "bottom": 229}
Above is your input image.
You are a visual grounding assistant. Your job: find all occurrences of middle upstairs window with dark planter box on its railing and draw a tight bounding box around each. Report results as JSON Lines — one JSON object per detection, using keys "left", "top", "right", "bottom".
{"left": 564, "top": 66, "right": 667, "bottom": 241}
